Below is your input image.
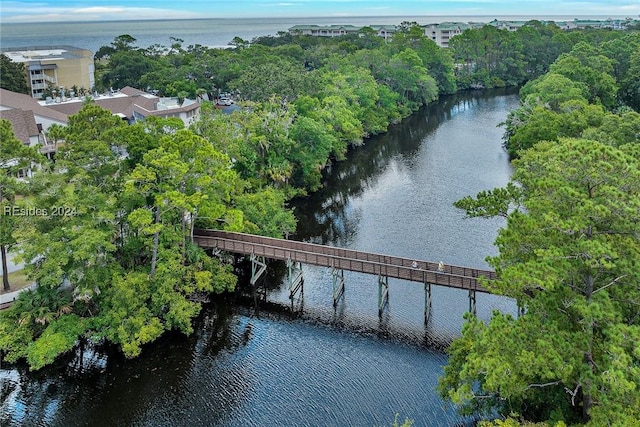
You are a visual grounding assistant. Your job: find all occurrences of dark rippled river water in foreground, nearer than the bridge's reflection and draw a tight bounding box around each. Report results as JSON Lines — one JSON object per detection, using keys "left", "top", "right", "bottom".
{"left": 0, "top": 306, "right": 472, "bottom": 426}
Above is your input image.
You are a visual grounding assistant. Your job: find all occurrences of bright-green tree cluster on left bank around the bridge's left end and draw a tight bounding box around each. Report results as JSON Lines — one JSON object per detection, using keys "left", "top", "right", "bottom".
{"left": 0, "top": 103, "right": 295, "bottom": 369}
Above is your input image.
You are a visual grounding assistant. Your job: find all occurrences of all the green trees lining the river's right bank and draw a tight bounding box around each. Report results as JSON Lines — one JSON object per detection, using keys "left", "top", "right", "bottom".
{"left": 439, "top": 27, "right": 640, "bottom": 426}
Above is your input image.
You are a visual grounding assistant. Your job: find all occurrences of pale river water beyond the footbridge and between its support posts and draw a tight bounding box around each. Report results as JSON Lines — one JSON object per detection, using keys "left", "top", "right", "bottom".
{"left": 270, "top": 91, "right": 518, "bottom": 347}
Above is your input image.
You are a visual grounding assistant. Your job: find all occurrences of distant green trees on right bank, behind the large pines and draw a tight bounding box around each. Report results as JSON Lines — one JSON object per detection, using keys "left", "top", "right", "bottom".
{"left": 503, "top": 36, "right": 638, "bottom": 157}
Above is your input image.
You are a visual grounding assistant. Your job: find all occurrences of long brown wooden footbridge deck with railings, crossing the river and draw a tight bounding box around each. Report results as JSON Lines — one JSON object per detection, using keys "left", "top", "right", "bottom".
{"left": 193, "top": 229, "right": 495, "bottom": 293}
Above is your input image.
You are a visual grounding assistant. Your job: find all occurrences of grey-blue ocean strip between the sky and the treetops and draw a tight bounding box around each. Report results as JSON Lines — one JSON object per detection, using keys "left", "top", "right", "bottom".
{"left": 0, "top": 15, "right": 625, "bottom": 53}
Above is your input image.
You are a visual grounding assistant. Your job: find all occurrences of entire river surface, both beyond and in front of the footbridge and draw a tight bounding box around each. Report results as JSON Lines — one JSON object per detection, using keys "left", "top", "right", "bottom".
{"left": 0, "top": 88, "right": 518, "bottom": 426}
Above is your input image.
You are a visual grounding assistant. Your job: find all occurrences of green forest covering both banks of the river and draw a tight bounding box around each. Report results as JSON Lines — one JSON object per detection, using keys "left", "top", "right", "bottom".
{"left": 0, "top": 21, "right": 640, "bottom": 425}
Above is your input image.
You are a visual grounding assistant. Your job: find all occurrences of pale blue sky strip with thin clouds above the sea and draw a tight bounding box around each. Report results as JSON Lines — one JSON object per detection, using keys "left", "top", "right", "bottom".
{"left": 0, "top": 0, "right": 640, "bottom": 23}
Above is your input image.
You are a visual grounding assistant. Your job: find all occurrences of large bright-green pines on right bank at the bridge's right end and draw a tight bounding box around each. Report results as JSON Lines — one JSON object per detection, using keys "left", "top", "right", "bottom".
{"left": 440, "top": 139, "right": 640, "bottom": 426}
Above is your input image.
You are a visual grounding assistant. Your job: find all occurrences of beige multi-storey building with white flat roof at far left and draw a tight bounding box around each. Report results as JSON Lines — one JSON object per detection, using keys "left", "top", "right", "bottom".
{"left": 2, "top": 46, "right": 95, "bottom": 98}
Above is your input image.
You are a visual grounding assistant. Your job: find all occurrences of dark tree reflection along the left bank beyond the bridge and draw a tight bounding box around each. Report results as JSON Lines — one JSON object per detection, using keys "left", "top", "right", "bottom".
{"left": 292, "top": 89, "right": 517, "bottom": 247}
